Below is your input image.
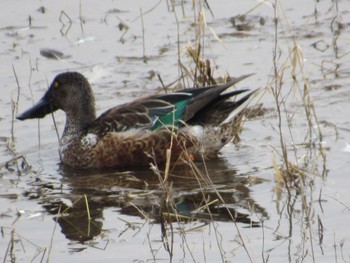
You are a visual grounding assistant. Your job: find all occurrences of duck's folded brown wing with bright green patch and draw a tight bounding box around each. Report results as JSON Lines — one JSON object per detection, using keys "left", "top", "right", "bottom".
{"left": 86, "top": 75, "right": 250, "bottom": 134}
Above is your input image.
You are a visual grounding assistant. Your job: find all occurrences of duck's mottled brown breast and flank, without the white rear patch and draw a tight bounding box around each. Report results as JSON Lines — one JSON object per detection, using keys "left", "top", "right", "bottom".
{"left": 61, "top": 129, "right": 199, "bottom": 168}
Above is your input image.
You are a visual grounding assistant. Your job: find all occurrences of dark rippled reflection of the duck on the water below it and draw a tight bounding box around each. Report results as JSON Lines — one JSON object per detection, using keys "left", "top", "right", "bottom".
{"left": 39, "top": 158, "right": 268, "bottom": 242}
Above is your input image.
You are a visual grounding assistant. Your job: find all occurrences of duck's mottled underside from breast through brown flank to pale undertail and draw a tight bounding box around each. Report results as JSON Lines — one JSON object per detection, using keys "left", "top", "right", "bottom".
{"left": 61, "top": 121, "right": 245, "bottom": 168}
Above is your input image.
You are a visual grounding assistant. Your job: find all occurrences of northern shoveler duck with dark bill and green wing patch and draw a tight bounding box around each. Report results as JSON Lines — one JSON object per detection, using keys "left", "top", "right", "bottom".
{"left": 17, "top": 72, "right": 253, "bottom": 168}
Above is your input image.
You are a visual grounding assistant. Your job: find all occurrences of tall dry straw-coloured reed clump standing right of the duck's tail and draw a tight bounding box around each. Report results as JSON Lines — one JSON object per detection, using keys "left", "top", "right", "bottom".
{"left": 271, "top": 0, "right": 326, "bottom": 262}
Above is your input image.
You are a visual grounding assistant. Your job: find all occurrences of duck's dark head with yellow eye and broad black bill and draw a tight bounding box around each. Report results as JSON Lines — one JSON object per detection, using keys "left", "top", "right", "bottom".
{"left": 17, "top": 72, "right": 95, "bottom": 120}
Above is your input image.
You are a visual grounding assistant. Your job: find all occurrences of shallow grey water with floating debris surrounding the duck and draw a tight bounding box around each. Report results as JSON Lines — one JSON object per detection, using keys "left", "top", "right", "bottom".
{"left": 0, "top": 0, "right": 350, "bottom": 262}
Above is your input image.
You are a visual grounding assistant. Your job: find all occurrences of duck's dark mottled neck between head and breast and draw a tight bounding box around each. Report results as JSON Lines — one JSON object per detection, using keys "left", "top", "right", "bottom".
{"left": 62, "top": 103, "right": 96, "bottom": 143}
